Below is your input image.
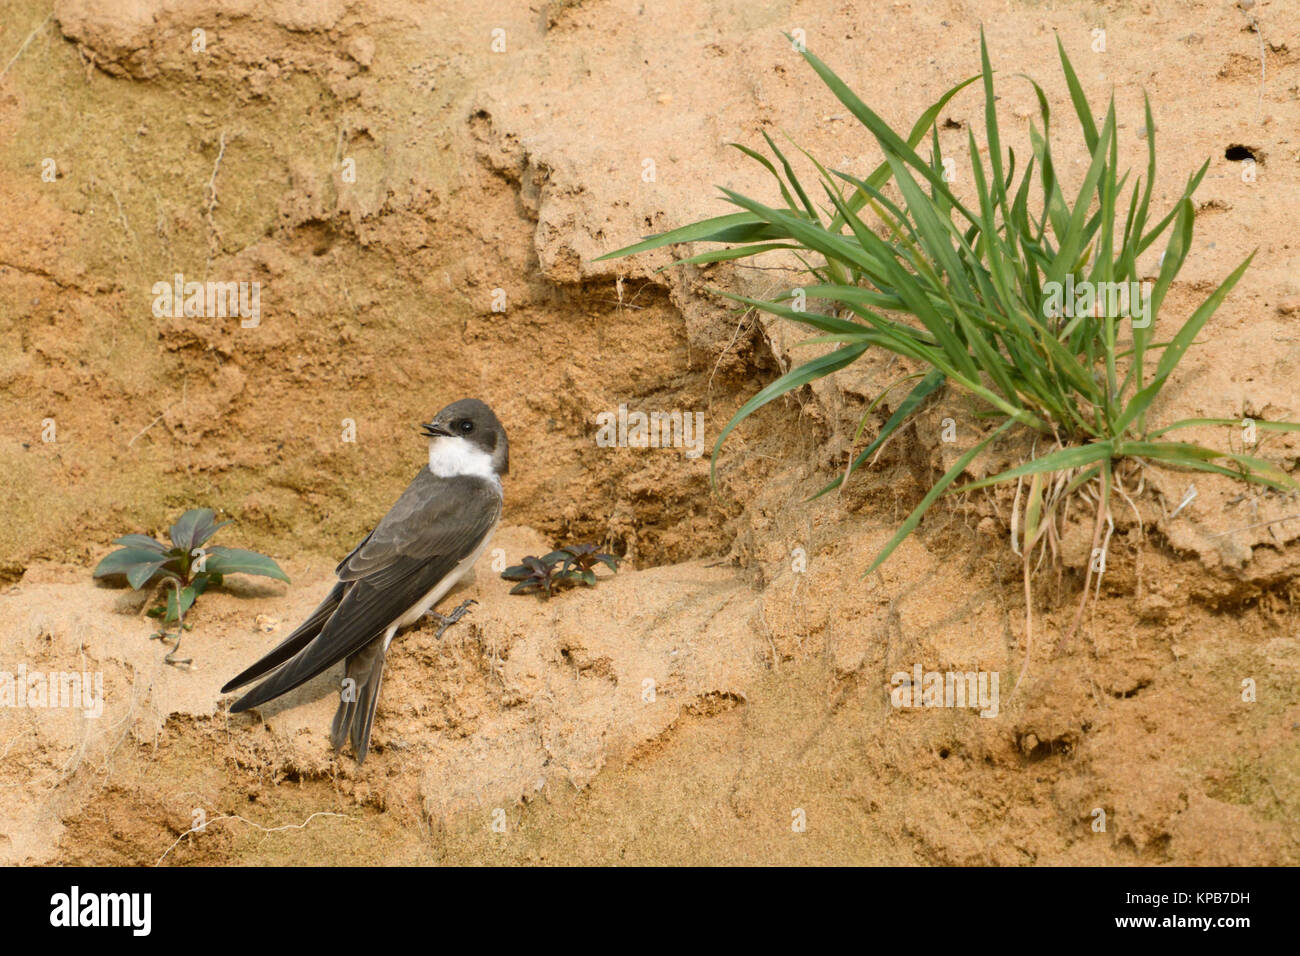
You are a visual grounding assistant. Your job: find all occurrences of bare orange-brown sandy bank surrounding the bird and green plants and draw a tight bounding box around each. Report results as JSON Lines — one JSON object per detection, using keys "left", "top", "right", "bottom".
{"left": 0, "top": 0, "right": 1300, "bottom": 865}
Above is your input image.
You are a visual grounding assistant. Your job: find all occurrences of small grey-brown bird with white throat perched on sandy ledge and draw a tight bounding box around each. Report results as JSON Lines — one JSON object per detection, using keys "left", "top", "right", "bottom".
{"left": 221, "top": 398, "right": 510, "bottom": 765}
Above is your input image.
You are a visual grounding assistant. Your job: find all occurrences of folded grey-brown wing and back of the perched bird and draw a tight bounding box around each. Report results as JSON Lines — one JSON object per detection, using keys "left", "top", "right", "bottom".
{"left": 230, "top": 468, "right": 501, "bottom": 711}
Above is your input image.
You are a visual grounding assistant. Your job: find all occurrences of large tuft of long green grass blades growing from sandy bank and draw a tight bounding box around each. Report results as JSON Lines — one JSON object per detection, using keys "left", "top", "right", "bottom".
{"left": 602, "top": 29, "right": 1300, "bottom": 587}
